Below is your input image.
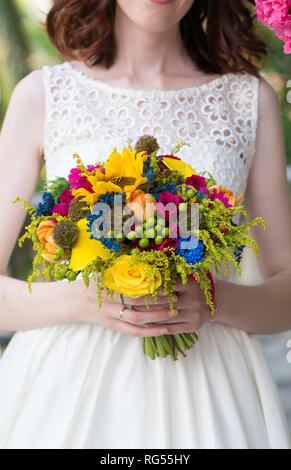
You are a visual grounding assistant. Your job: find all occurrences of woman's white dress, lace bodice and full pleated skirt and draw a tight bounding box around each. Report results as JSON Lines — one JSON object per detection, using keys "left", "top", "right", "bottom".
{"left": 0, "top": 62, "right": 291, "bottom": 449}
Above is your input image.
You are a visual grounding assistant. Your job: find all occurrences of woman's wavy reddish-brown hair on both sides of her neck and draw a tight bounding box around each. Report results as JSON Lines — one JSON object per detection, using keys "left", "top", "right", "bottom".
{"left": 46, "top": 0, "right": 267, "bottom": 75}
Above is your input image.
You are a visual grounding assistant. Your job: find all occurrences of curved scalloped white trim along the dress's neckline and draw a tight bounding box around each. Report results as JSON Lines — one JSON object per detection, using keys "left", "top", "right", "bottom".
{"left": 66, "top": 61, "right": 232, "bottom": 96}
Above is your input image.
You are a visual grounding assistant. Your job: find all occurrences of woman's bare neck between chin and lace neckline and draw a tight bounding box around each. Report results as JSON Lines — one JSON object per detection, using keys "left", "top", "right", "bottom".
{"left": 114, "top": 5, "right": 195, "bottom": 85}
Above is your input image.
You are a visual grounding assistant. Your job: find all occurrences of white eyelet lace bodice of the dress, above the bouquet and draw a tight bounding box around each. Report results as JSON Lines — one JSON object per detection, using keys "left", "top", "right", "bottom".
{"left": 43, "top": 62, "right": 259, "bottom": 200}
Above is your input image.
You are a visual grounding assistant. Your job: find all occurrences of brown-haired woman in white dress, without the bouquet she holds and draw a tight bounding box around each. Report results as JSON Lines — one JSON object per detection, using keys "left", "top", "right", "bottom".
{"left": 0, "top": 0, "right": 291, "bottom": 449}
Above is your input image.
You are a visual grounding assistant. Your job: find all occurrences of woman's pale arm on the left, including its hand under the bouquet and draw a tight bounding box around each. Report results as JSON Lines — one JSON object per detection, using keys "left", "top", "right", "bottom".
{"left": 0, "top": 71, "right": 169, "bottom": 336}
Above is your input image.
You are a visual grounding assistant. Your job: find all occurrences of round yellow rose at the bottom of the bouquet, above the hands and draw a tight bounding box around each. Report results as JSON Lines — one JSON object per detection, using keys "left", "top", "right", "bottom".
{"left": 104, "top": 255, "right": 162, "bottom": 297}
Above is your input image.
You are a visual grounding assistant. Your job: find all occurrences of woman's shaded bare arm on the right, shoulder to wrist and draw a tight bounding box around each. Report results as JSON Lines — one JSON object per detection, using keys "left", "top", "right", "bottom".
{"left": 216, "top": 80, "right": 291, "bottom": 333}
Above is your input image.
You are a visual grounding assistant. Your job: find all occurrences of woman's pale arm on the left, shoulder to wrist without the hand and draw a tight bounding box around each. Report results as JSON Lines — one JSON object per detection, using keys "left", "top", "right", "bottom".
{"left": 0, "top": 71, "right": 72, "bottom": 330}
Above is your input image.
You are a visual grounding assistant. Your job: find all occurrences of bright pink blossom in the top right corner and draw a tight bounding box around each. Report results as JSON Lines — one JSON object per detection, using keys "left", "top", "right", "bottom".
{"left": 256, "top": 0, "right": 291, "bottom": 54}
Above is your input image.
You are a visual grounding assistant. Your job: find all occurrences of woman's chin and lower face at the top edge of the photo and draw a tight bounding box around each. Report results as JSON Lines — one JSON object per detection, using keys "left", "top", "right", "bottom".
{"left": 117, "top": 0, "right": 194, "bottom": 33}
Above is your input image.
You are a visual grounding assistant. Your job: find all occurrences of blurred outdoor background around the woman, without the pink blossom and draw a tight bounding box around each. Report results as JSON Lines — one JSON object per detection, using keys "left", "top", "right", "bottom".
{"left": 0, "top": 0, "right": 291, "bottom": 429}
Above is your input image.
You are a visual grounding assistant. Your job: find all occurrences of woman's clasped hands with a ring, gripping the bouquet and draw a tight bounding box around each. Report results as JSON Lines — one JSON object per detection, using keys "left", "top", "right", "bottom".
{"left": 73, "top": 279, "right": 211, "bottom": 337}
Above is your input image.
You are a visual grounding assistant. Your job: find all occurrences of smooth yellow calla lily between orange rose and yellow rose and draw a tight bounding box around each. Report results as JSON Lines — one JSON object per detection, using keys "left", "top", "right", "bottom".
{"left": 70, "top": 219, "right": 111, "bottom": 271}
